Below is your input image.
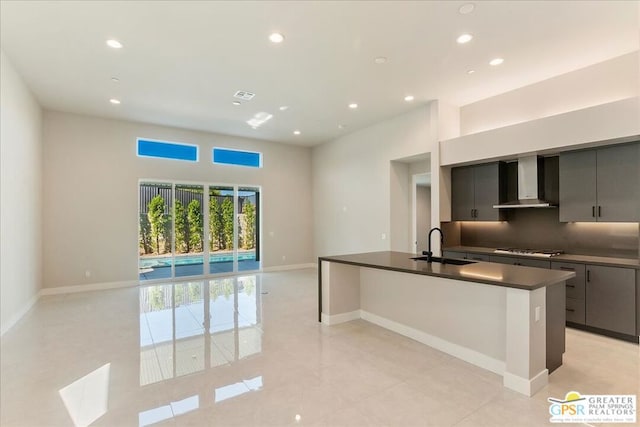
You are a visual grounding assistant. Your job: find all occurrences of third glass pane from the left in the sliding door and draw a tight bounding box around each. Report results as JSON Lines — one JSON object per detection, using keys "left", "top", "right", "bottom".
{"left": 209, "top": 187, "right": 234, "bottom": 274}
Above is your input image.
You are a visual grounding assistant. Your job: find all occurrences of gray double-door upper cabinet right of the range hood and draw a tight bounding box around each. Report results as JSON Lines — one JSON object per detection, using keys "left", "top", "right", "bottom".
{"left": 560, "top": 143, "right": 640, "bottom": 222}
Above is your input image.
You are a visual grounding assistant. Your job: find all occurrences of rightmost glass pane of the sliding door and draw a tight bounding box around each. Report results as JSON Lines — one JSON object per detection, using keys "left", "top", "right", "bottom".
{"left": 238, "top": 188, "right": 260, "bottom": 271}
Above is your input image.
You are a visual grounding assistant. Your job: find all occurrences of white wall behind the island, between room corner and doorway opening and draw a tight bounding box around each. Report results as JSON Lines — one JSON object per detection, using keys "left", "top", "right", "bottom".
{"left": 313, "top": 105, "right": 437, "bottom": 256}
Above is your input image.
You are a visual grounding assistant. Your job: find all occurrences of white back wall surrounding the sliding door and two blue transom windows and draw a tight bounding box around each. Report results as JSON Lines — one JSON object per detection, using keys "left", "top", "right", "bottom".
{"left": 43, "top": 111, "right": 314, "bottom": 288}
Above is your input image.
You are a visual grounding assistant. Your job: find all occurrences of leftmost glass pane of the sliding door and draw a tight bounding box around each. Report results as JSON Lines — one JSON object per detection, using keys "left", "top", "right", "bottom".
{"left": 138, "top": 183, "right": 173, "bottom": 280}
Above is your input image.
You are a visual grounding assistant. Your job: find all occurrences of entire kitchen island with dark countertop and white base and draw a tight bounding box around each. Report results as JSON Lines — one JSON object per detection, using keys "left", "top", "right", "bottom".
{"left": 318, "top": 252, "right": 575, "bottom": 396}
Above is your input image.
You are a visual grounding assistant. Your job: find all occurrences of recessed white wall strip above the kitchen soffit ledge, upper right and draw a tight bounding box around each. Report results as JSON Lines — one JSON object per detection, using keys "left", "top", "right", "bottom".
{"left": 462, "top": 51, "right": 640, "bottom": 135}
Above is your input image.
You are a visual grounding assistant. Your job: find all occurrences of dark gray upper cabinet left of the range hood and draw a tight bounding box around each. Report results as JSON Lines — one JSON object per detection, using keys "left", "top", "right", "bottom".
{"left": 451, "top": 162, "right": 506, "bottom": 221}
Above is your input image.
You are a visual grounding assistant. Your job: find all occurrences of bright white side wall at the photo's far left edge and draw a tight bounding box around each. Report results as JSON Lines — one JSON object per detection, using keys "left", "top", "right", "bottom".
{"left": 0, "top": 52, "right": 42, "bottom": 334}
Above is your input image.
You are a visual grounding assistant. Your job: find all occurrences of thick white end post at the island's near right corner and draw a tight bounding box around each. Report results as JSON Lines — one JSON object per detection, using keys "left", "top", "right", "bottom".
{"left": 503, "top": 288, "right": 549, "bottom": 396}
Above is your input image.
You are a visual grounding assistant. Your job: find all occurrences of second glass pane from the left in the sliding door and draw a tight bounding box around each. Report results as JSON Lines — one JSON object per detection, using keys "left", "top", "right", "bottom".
{"left": 173, "top": 184, "right": 204, "bottom": 277}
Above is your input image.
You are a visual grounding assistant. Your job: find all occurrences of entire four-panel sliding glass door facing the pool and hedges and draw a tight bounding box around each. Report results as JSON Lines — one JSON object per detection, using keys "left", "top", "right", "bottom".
{"left": 138, "top": 182, "right": 260, "bottom": 280}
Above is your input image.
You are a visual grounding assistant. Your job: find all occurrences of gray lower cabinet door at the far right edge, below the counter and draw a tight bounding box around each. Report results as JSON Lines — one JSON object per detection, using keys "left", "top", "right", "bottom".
{"left": 586, "top": 265, "right": 637, "bottom": 335}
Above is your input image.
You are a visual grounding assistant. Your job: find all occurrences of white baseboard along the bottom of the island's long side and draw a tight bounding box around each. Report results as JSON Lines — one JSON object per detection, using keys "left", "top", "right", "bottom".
{"left": 360, "top": 310, "right": 505, "bottom": 375}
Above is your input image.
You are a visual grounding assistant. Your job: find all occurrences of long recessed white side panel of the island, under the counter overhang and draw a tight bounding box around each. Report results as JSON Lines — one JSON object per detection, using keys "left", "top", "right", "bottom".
{"left": 360, "top": 268, "right": 504, "bottom": 375}
